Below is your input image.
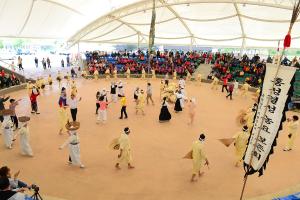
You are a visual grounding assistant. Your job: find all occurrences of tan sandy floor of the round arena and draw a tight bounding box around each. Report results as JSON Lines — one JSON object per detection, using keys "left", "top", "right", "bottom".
{"left": 0, "top": 79, "right": 300, "bottom": 200}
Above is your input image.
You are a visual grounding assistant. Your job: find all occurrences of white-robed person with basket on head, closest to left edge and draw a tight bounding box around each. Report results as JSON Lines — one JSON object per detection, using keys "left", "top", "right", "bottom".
{"left": 0, "top": 109, "right": 14, "bottom": 149}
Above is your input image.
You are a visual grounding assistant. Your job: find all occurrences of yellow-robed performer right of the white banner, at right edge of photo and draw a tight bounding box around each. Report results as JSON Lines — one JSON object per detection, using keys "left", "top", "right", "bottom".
{"left": 283, "top": 115, "right": 299, "bottom": 151}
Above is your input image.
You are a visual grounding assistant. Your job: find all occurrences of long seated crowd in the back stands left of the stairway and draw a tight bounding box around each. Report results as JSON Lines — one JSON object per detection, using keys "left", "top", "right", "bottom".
{"left": 86, "top": 50, "right": 209, "bottom": 76}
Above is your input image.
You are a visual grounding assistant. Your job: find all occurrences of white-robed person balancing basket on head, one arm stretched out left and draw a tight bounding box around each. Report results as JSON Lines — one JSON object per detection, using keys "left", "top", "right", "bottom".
{"left": 59, "top": 122, "right": 84, "bottom": 168}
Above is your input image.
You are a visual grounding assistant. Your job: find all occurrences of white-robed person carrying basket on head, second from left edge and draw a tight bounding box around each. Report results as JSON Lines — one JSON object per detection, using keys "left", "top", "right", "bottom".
{"left": 19, "top": 116, "right": 33, "bottom": 156}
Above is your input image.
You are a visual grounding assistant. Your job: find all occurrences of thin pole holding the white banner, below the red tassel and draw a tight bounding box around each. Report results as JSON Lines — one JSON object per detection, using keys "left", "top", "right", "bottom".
{"left": 240, "top": 48, "right": 285, "bottom": 200}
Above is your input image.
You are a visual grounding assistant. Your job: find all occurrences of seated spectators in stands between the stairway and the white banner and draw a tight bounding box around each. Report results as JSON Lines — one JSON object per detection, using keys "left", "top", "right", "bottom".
{"left": 208, "top": 54, "right": 266, "bottom": 87}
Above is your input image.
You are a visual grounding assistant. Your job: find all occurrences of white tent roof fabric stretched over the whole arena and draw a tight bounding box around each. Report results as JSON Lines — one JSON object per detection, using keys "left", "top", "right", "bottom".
{"left": 0, "top": 0, "right": 300, "bottom": 48}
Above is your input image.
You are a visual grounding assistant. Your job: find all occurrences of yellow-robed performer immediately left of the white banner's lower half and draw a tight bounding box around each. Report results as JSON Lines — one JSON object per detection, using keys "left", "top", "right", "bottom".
{"left": 233, "top": 126, "right": 250, "bottom": 167}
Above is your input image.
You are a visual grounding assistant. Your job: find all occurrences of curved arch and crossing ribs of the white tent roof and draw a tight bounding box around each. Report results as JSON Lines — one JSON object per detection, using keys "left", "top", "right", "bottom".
{"left": 68, "top": 0, "right": 300, "bottom": 47}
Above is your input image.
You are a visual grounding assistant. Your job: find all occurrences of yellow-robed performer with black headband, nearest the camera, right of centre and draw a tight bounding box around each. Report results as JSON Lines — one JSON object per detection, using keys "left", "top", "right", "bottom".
{"left": 191, "top": 133, "right": 209, "bottom": 182}
